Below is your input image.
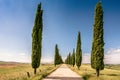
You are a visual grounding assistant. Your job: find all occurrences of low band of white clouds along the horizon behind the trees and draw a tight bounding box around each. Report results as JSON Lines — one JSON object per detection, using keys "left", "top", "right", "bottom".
{"left": 0, "top": 49, "right": 120, "bottom": 64}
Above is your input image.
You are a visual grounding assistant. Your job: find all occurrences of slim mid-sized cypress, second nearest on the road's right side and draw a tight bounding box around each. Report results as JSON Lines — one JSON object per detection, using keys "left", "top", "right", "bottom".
{"left": 76, "top": 32, "right": 82, "bottom": 69}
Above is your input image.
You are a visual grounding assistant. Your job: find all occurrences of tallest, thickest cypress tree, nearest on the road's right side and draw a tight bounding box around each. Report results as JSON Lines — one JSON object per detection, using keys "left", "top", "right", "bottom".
{"left": 91, "top": 2, "right": 104, "bottom": 77}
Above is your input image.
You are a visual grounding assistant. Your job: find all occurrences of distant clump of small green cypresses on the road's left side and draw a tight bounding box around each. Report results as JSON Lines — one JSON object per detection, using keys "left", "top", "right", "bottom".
{"left": 54, "top": 44, "right": 63, "bottom": 66}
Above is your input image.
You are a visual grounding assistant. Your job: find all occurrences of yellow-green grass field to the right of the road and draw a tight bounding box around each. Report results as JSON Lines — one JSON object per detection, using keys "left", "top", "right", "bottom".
{"left": 68, "top": 64, "right": 120, "bottom": 80}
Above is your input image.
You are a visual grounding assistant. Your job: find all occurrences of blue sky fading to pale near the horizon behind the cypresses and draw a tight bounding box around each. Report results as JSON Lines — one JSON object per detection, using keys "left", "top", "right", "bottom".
{"left": 0, "top": 0, "right": 120, "bottom": 62}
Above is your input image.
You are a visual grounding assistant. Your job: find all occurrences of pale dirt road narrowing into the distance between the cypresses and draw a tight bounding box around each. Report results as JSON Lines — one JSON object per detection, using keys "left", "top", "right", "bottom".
{"left": 43, "top": 64, "right": 83, "bottom": 80}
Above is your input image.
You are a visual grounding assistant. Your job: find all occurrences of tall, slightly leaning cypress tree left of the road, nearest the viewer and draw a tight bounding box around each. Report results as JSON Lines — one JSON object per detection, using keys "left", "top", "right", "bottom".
{"left": 31, "top": 3, "right": 43, "bottom": 74}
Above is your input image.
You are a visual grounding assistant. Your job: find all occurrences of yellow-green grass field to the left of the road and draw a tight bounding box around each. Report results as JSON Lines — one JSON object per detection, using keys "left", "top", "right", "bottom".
{"left": 0, "top": 62, "right": 60, "bottom": 80}
